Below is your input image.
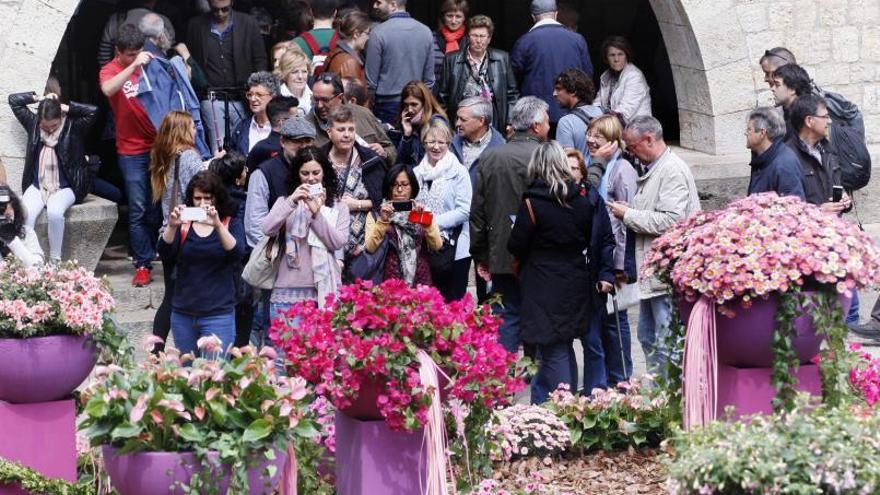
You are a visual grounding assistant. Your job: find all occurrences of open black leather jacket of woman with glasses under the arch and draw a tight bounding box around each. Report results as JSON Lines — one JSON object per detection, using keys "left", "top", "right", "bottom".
{"left": 437, "top": 47, "right": 519, "bottom": 131}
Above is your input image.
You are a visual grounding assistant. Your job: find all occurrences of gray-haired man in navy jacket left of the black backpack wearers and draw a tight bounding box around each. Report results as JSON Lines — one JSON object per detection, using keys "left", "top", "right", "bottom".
{"left": 745, "top": 107, "right": 804, "bottom": 200}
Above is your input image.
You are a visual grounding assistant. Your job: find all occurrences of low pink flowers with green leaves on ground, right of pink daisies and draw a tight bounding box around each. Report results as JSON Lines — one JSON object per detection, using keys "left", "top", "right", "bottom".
{"left": 547, "top": 374, "right": 675, "bottom": 451}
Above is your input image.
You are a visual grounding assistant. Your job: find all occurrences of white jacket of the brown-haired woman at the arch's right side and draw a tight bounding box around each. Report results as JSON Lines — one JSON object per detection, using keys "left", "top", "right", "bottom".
{"left": 593, "top": 64, "right": 651, "bottom": 122}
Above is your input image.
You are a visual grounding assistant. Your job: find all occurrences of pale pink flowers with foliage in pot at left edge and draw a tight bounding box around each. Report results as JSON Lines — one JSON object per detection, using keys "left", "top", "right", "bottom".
{"left": 0, "top": 259, "right": 113, "bottom": 338}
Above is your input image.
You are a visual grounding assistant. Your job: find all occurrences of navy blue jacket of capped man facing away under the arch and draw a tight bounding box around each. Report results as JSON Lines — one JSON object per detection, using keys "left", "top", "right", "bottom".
{"left": 510, "top": 23, "right": 593, "bottom": 122}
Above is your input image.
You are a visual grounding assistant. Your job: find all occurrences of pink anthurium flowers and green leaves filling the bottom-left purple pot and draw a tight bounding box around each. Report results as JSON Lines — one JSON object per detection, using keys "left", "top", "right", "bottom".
{"left": 78, "top": 337, "right": 317, "bottom": 493}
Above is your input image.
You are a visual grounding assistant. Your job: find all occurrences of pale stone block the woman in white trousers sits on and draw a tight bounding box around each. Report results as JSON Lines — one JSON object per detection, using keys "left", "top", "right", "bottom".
{"left": 35, "top": 195, "right": 117, "bottom": 270}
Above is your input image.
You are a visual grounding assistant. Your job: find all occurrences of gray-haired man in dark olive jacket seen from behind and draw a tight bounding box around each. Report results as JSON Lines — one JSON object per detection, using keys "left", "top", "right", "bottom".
{"left": 470, "top": 96, "right": 550, "bottom": 352}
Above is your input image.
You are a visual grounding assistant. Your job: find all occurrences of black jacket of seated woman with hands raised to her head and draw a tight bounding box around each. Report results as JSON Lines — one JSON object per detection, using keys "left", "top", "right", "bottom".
{"left": 9, "top": 92, "right": 98, "bottom": 203}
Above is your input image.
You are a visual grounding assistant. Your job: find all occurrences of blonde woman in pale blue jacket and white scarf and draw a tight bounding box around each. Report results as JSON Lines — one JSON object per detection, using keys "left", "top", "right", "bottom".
{"left": 413, "top": 119, "right": 473, "bottom": 301}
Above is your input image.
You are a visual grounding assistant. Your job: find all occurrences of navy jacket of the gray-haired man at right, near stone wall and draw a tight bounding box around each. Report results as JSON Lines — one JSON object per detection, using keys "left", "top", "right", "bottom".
{"left": 748, "top": 138, "right": 804, "bottom": 199}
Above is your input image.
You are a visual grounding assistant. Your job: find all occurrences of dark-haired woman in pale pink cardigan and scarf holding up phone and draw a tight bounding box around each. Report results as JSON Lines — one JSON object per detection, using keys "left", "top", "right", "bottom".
{"left": 263, "top": 146, "right": 350, "bottom": 319}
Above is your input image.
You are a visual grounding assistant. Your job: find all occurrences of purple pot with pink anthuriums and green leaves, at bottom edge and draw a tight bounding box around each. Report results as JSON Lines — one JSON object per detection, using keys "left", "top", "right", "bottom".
{"left": 78, "top": 337, "right": 317, "bottom": 495}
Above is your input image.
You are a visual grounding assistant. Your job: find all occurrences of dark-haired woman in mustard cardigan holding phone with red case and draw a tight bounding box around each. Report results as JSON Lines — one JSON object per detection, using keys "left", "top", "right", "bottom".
{"left": 366, "top": 164, "right": 443, "bottom": 286}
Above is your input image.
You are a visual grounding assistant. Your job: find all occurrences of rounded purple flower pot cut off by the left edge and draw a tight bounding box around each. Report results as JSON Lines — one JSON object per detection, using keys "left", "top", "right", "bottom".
{"left": 0, "top": 335, "right": 98, "bottom": 404}
